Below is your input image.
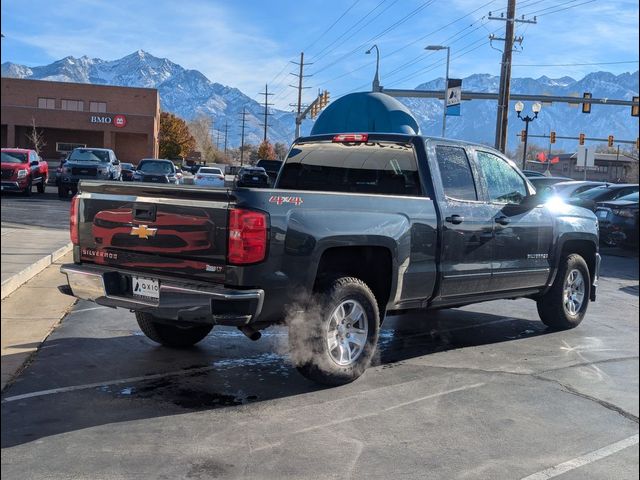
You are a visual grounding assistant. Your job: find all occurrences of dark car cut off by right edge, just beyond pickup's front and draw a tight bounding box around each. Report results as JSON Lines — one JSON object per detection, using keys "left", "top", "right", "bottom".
{"left": 596, "top": 192, "right": 638, "bottom": 247}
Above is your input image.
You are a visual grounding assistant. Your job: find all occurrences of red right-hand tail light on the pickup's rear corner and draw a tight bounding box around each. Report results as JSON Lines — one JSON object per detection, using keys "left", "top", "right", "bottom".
{"left": 227, "top": 208, "right": 267, "bottom": 265}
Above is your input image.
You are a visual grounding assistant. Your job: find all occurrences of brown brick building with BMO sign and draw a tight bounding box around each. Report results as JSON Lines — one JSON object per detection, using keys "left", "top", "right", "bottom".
{"left": 1, "top": 78, "right": 160, "bottom": 163}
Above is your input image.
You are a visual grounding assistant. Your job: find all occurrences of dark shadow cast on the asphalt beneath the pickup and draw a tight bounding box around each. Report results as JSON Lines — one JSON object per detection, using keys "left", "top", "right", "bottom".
{"left": 1, "top": 309, "right": 549, "bottom": 448}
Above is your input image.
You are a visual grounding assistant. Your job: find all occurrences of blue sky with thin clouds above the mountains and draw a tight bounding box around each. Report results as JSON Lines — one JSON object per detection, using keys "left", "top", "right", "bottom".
{"left": 1, "top": 0, "right": 639, "bottom": 108}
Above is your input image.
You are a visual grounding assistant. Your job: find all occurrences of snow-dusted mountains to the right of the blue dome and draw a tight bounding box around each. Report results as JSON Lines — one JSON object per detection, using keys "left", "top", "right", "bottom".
{"left": 408, "top": 72, "right": 639, "bottom": 150}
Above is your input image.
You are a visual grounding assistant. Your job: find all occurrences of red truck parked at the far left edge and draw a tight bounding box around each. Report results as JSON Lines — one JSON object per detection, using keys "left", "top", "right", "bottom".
{"left": 2, "top": 148, "right": 49, "bottom": 196}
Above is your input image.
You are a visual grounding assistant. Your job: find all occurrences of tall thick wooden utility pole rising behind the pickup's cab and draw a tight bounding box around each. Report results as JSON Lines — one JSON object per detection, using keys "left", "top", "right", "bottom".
{"left": 488, "top": 0, "right": 537, "bottom": 153}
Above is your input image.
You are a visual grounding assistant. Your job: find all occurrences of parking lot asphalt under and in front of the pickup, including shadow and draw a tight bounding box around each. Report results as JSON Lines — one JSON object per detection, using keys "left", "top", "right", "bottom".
{"left": 1, "top": 256, "right": 638, "bottom": 479}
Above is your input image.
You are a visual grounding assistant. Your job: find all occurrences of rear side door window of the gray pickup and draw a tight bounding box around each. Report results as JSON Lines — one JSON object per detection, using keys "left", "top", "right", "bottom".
{"left": 436, "top": 145, "right": 478, "bottom": 200}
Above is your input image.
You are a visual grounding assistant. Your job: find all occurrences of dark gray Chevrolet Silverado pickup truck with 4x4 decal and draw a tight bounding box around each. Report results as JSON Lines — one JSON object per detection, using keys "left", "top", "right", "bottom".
{"left": 61, "top": 133, "right": 600, "bottom": 385}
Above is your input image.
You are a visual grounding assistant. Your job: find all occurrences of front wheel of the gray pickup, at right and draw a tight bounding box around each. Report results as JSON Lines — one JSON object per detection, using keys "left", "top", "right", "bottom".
{"left": 537, "top": 253, "right": 591, "bottom": 330}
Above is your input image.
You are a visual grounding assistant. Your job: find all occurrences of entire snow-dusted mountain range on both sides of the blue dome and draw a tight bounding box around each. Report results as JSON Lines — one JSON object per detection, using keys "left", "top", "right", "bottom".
{"left": 2, "top": 50, "right": 638, "bottom": 149}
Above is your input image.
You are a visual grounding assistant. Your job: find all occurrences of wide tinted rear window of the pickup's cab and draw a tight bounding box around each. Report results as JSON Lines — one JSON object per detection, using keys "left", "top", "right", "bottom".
{"left": 278, "top": 139, "right": 422, "bottom": 196}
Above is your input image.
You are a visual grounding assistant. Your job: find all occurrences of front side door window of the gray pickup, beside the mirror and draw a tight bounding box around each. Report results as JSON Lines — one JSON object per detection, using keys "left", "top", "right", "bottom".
{"left": 478, "top": 151, "right": 527, "bottom": 203}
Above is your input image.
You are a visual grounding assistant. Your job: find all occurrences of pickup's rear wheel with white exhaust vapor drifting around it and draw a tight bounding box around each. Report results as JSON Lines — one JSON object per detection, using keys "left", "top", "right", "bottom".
{"left": 288, "top": 277, "right": 380, "bottom": 386}
